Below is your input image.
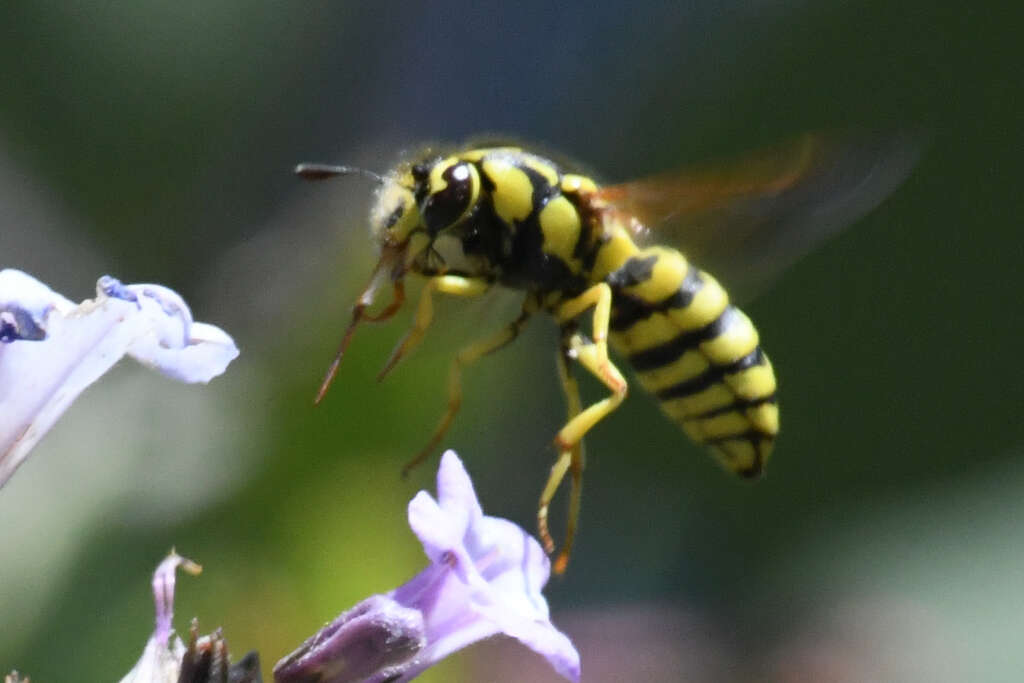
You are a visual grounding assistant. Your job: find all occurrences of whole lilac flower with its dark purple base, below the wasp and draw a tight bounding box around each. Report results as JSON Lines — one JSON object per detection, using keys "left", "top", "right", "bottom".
{"left": 274, "top": 451, "right": 580, "bottom": 683}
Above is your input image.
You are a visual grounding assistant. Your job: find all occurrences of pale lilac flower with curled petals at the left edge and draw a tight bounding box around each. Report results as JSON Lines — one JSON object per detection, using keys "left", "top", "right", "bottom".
{"left": 0, "top": 269, "right": 239, "bottom": 486}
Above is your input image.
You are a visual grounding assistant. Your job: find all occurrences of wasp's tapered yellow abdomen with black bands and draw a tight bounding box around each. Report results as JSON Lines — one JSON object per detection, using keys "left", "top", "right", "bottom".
{"left": 605, "top": 247, "right": 778, "bottom": 476}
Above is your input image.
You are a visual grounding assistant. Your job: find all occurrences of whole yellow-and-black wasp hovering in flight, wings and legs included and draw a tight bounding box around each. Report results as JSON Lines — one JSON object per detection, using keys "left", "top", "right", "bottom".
{"left": 296, "top": 134, "right": 913, "bottom": 572}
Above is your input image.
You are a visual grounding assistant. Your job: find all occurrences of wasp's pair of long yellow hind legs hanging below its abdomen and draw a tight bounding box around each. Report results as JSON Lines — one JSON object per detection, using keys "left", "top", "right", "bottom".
{"left": 537, "top": 283, "right": 628, "bottom": 572}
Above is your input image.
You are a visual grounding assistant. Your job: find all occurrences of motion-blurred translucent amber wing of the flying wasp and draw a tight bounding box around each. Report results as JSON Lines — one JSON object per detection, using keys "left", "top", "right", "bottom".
{"left": 598, "top": 134, "right": 922, "bottom": 299}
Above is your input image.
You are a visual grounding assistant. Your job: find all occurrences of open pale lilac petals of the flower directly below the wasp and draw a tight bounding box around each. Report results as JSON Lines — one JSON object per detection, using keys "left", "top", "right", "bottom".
{"left": 279, "top": 451, "right": 580, "bottom": 683}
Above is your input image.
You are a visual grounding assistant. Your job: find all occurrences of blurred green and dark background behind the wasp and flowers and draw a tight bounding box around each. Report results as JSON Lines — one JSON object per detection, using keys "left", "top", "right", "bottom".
{"left": 0, "top": 0, "right": 1024, "bottom": 681}
